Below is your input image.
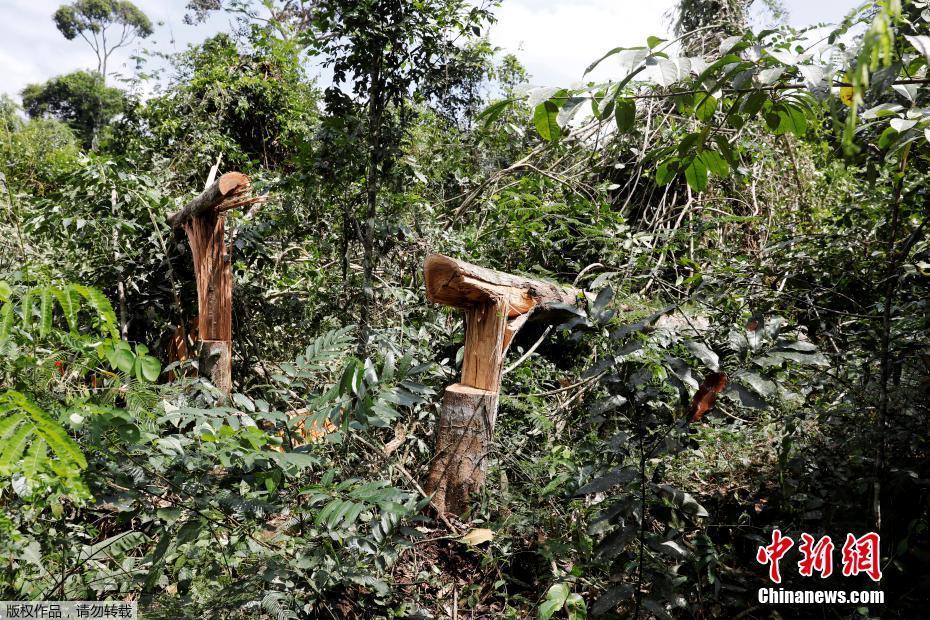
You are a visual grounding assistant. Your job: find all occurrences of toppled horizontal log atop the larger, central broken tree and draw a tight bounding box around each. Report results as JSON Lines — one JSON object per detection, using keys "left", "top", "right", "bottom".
{"left": 423, "top": 254, "right": 578, "bottom": 318}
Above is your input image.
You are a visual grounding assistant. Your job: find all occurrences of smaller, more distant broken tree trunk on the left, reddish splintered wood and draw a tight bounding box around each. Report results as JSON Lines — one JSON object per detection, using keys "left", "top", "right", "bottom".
{"left": 168, "top": 172, "right": 265, "bottom": 395}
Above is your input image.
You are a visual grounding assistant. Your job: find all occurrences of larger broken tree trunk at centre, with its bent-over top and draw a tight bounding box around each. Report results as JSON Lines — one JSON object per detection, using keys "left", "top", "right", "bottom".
{"left": 423, "top": 254, "right": 584, "bottom": 514}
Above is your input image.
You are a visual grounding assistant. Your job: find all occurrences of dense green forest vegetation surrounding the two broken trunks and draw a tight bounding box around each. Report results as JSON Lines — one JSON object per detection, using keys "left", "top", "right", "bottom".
{"left": 0, "top": 0, "right": 930, "bottom": 620}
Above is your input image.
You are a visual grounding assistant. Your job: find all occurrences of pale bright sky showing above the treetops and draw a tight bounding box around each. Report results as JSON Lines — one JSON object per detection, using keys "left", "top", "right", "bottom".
{"left": 0, "top": 0, "right": 860, "bottom": 94}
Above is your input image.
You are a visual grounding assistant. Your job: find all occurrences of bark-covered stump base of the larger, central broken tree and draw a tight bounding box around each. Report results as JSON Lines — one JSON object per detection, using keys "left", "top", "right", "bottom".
{"left": 426, "top": 383, "right": 497, "bottom": 514}
